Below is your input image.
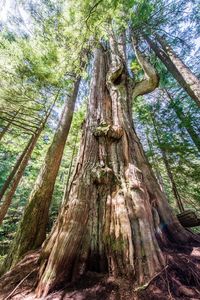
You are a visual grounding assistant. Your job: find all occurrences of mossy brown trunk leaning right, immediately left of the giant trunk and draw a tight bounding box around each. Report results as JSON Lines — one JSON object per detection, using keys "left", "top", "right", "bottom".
{"left": 4, "top": 78, "right": 80, "bottom": 269}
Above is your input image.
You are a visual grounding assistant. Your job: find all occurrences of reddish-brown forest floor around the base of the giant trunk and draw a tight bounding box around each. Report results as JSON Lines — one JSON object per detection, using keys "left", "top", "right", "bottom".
{"left": 0, "top": 247, "right": 200, "bottom": 300}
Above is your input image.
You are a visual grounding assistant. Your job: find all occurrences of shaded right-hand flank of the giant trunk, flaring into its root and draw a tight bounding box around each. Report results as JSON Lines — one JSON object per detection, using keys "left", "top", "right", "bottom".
{"left": 130, "top": 126, "right": 193, "bottom": 245}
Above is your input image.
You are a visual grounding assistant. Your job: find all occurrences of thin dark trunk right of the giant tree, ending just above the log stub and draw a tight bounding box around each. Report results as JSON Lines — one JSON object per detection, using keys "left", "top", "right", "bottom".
{"left": 151, "top": 113, "right": 184, "bottom": 212}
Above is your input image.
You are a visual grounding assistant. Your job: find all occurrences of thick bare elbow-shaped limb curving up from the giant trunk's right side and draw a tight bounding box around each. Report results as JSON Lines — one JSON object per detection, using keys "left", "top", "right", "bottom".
{"left": 132, "top": 37, "right": 159, "bottom": 99}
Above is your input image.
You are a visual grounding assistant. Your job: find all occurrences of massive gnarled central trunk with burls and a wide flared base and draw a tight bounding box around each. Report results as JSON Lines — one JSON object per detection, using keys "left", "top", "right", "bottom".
{"left": 34, "top": 44, "right": 195, "bottom": 296}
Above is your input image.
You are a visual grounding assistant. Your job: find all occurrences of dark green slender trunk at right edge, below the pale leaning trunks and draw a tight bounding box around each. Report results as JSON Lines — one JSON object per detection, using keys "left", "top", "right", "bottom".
{"left": 165, "top": 90, "right": 200, "bottom": 152}
